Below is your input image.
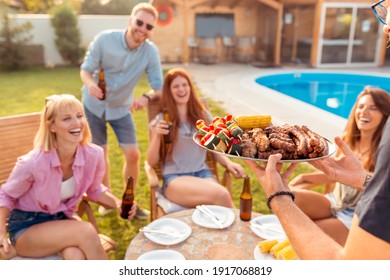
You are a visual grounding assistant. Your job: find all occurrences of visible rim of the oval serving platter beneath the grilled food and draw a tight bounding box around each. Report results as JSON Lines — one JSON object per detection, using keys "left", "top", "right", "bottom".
{"left": 192, "top": 132, "right": 337, "bottom": 163}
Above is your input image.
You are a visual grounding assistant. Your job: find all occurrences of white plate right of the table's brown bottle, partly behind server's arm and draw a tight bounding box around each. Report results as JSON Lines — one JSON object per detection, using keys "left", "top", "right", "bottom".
{"left": 250, "top": 215, "right": 287, "bottom": 241}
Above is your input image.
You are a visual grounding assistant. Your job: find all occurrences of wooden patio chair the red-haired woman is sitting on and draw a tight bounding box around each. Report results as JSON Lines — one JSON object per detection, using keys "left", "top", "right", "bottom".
{"left": 144, "top": 95, "right": 232, "bottom": 221}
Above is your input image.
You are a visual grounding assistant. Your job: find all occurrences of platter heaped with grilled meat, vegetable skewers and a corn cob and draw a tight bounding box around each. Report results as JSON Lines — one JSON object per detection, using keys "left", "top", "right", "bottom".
{"left": 194, "top": 114, "right": 336, "bottom": 162}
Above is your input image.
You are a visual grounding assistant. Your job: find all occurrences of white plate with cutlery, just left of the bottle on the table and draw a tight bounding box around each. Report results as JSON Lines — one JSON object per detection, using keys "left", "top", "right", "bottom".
{"left": 192, "top": 205, "right": 235, "bottom": 229}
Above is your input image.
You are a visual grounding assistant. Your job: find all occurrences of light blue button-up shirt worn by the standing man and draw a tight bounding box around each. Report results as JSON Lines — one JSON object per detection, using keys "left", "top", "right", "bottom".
{"left": 81, "top": 30, "right": 163, "bottom": 120}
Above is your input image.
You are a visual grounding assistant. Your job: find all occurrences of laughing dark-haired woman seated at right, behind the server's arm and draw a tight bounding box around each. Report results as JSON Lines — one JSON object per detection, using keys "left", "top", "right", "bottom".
{"left": 290, "top": 87, "right": 390, "bottom": 245}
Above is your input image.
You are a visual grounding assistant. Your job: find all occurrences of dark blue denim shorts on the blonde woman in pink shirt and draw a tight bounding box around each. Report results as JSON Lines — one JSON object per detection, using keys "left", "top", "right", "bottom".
{"left": 8, "top": 209, "right": 67, "bottom": 245}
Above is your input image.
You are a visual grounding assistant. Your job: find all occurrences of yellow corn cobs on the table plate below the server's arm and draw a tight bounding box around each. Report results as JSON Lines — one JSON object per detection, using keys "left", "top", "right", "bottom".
{"left": 257, "top": 239, "right": 298, "bottom": 260}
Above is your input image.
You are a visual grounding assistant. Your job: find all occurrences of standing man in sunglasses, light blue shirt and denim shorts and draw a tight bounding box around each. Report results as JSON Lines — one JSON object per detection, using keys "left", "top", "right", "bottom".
{"left": 80, "top": 3, "right": 163, "bottom": 219}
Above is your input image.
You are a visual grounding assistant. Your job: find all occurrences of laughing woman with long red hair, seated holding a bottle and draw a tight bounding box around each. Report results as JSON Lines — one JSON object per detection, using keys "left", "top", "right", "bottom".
{"left": 147, "top": 69, "right": 245, "bottom": 207}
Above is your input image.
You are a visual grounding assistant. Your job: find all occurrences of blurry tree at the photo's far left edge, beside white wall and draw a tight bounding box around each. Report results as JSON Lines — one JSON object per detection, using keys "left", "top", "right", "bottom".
{"left": 0, "top": 5, "right": 32, "bottom": 70}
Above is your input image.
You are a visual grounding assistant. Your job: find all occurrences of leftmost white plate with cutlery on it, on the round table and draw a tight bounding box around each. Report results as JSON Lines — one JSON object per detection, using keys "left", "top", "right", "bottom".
{"left": 144, "top": 218, "right": 192, "bottom": 245}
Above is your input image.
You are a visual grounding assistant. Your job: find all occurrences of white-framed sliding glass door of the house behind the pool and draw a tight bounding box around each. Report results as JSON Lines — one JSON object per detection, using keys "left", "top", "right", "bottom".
{"left": 317, "top": 3, "right": 382, "bottom": 66}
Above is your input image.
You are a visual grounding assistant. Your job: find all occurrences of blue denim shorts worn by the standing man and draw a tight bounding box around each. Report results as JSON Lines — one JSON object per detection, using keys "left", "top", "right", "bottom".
{"left": 84, "top": 106, "right": 138, "bottom": 148}
